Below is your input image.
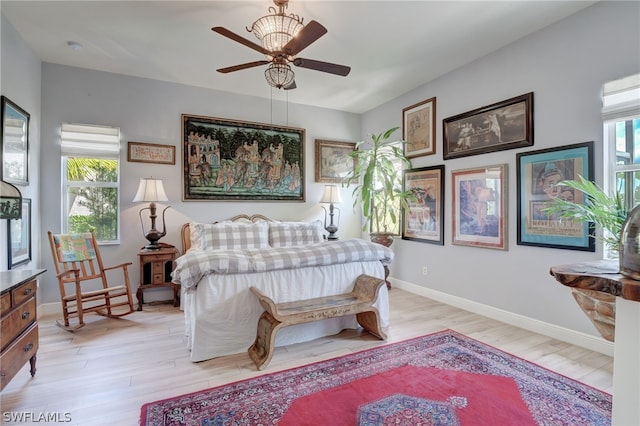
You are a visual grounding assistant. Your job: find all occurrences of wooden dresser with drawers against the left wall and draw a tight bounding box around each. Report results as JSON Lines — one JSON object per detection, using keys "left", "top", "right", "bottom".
{"left": 0, "top": 269, "right": 46, "bottom": 390}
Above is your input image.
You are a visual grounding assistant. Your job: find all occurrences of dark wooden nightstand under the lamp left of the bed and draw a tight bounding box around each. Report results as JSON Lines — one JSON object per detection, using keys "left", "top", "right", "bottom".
{"left": 136, "top": 247, "right": 180, "bottom": 311}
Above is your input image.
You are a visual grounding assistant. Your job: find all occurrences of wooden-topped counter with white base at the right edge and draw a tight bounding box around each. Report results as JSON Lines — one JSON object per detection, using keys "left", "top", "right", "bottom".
{"left": 550, "top": 260, "right": 640, "bottom": 425}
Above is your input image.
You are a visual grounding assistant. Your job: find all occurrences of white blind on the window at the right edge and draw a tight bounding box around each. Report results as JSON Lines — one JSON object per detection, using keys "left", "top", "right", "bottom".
{"left": 602, "top": 74, "right": 640, "bottom": 121}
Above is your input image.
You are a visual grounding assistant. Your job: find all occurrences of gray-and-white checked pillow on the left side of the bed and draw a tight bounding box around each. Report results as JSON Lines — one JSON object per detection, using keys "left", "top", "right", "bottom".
{"left": 189, "top": 222, "right": 269, "bottom": 250}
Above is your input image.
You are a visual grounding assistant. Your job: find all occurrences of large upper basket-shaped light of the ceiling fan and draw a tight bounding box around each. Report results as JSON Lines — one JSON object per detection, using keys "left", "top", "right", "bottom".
{"left": 247, "top": 6, "right": 304, "bottom": 52}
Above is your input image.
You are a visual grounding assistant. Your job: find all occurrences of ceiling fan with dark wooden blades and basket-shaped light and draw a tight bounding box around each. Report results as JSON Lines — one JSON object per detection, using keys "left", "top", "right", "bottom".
{"left": 211, "top": 0, "right": 351, "bottom": 90}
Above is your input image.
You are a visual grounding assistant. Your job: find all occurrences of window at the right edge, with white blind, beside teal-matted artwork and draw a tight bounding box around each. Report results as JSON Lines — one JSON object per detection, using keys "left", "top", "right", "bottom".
{"left": 602, "top": 74, "right": 640, "bottom": 255}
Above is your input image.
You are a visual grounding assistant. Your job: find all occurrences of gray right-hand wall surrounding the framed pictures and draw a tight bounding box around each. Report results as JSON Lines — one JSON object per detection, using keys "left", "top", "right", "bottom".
{"left": 363, "top": 2, "right": 640, "bottom": 335}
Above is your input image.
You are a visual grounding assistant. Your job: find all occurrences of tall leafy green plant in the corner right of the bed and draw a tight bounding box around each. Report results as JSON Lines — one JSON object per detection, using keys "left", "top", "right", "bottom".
{"left": 344, "top": 127, "right": 413, "bottom": 246}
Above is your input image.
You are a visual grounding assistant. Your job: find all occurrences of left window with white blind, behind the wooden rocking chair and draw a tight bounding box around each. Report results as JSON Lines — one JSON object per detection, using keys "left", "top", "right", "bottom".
{"left": 61, "top": 123, "right": 120, "bottom": 243}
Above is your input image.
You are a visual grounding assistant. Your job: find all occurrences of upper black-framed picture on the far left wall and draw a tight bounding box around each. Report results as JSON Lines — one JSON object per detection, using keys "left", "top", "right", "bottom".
{"left": 0, "top": 96, "right": 31, "bottom": 185}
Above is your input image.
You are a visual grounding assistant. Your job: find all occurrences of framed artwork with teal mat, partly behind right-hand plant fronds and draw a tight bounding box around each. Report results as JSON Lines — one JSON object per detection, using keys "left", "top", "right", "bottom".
{"left": 516, "top": 142, "right": 595, "bottom": 251}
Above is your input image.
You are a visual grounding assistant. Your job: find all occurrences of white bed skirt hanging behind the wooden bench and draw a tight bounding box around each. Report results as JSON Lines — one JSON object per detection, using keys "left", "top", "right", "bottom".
{"left": 182, "top": 261, "right": 389, "bottom": 362}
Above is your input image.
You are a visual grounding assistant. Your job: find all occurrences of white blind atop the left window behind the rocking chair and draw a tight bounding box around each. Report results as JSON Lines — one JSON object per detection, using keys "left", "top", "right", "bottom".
{"left": 61, "top": 123, "right": 120, "bottom": 156}
